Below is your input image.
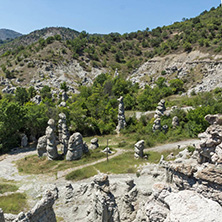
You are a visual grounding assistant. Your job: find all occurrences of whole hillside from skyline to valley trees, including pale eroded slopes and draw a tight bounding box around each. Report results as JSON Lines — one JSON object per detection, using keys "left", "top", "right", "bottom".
{"left": 0, "top": 7, "right": 222, "bottom": 91}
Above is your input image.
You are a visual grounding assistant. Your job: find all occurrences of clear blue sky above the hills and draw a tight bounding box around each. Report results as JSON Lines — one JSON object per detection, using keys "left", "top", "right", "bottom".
{"left": 0, "top": 0, "right": 221, "bottom": 34}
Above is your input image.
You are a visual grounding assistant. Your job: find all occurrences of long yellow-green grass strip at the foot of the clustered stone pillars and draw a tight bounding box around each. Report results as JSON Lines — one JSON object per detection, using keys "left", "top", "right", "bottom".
{"left": 16, "top": 147, "right": 106, "bottom": 174}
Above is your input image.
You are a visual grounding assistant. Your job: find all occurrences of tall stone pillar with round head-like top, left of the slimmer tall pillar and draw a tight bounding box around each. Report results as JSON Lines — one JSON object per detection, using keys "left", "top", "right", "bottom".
{"left": 45, "top": 119, "right": 58, "bottom": 160}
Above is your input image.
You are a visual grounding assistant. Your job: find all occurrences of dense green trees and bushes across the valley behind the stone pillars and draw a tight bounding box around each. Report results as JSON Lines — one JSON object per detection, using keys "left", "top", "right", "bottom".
{"left": 0, "top": 71, "right": 222, "bottom": 153}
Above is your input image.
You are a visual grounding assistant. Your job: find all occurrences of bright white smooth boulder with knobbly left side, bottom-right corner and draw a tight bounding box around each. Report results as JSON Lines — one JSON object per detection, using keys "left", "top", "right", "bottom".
{"left": 134, "top": 183, "right": 222, "bottom": 222}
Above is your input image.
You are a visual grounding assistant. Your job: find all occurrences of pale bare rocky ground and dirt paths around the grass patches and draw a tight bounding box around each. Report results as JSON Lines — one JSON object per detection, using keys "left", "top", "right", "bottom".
{"left": 0, "top": 140, "right": 209, "bottom": 222}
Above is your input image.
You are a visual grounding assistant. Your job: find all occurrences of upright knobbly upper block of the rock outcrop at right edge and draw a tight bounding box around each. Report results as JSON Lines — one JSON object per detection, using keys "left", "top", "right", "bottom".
{"left": 196, "top": 115, "right": 222, "bottom": 164}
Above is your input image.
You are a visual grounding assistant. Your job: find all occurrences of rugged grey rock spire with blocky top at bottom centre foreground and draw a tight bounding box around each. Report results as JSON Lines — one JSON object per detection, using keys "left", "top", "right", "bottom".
{"left": 88, "top": 175, "right": 120, "bottom": 222}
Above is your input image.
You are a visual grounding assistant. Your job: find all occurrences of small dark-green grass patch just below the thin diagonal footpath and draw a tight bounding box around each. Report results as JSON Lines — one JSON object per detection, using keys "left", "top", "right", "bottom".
{"left": 66, "top": 166, "right": 98, "bottom": 181}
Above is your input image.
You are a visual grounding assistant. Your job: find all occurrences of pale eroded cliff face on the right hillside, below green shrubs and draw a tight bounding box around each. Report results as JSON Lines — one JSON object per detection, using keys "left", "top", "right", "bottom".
{"left": 128, "top": 51, "right": 222, "bottom": 94}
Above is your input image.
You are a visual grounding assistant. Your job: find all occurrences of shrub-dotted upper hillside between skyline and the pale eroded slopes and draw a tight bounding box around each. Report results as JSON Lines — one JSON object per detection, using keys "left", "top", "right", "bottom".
{"left": 0, "top": 4, "right": 222, "bottom": 87}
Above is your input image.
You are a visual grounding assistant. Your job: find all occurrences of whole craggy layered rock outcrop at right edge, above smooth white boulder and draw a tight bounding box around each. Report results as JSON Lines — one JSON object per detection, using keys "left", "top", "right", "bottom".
{"left": 163, "top": 115, "right": 222, "bottom": 206}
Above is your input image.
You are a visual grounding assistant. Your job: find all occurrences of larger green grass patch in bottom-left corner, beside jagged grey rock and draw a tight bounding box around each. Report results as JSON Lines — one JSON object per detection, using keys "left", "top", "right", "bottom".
{"left": 0, "top": 193, "right": 27, "bottom": 214}
